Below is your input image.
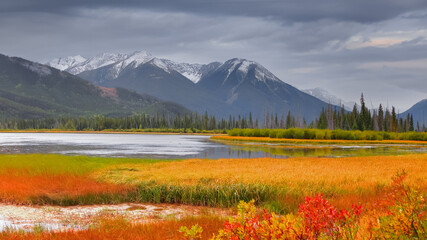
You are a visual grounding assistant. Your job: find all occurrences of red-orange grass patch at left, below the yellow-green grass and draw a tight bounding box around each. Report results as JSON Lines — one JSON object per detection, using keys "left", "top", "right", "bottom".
{"left": 0, "top": 174, "right": 133, "bottom": 204}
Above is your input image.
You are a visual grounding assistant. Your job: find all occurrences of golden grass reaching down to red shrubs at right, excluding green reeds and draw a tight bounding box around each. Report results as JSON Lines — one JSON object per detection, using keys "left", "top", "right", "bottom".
{"left": 93, "top": 154, "right": 427, "bottom": 212}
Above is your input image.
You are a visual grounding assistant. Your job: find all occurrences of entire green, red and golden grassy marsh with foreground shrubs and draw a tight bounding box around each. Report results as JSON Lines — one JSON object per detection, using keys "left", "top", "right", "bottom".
{"left": 0, "top": 151, "right": 427, "bottom": 239}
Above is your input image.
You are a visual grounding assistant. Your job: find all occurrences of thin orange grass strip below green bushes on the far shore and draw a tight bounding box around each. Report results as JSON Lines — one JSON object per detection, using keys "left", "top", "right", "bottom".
{"left": 211, "top": 136, "right": 427, "bottom": 145}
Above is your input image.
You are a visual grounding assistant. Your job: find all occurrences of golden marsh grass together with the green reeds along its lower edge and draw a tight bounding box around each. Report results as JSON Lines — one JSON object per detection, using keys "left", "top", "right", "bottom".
{"left": 96, "top": 154, "right": 427, "bottom": 213}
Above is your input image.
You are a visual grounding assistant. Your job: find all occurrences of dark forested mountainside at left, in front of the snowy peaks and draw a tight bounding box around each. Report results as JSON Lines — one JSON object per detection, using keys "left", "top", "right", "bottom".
{"left": 0, "top": 54, "right": 189, "bottom": 118}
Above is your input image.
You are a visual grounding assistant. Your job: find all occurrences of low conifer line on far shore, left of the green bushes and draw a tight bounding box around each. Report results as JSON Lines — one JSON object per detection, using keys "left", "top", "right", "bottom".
{"left": 0, "top": 112, "right": 258, "bottom": 132}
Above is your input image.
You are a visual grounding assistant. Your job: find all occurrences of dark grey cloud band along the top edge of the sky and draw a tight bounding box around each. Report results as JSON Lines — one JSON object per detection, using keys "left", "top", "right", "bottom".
{"left": 0, "top": 0, "right": 427, "bottom": 22}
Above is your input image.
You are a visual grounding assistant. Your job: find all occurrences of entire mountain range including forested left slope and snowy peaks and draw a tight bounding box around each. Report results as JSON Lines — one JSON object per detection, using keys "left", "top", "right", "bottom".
{"left": 0, "top": 51, "right": 427, "bottom": 123}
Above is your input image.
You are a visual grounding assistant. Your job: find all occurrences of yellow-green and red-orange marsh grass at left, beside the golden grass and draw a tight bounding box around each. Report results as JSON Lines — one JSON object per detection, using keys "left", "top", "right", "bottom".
{"left": 0, "top": 154, "right": 158, "bottom": 206}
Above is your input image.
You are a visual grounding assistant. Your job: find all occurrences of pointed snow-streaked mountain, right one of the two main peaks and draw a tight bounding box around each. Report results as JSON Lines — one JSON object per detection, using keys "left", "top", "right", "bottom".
{"left": 197, "top": 58, "right": 327, "bottom": 121}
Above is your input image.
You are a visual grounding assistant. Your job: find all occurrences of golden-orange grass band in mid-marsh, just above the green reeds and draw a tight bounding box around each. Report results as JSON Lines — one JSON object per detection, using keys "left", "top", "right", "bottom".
{"left": 94, "top": 154, "right": 427, "bottom": 190}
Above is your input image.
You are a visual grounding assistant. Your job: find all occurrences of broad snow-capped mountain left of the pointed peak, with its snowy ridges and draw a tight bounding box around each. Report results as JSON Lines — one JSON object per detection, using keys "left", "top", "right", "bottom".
{"left": 78, "top": 51, "right": 238, "bottom": 117}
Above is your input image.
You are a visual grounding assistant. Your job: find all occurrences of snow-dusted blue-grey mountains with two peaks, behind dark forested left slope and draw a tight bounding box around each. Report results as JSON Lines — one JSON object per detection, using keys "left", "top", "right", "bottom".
{"left": 47, "top": 51, "right": 334, "bottom": 122}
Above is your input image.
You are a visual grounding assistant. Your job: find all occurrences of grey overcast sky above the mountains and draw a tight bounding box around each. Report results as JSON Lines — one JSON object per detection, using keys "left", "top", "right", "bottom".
{"left": 0, "top": 0, "right": 427, "bottom": 112}
